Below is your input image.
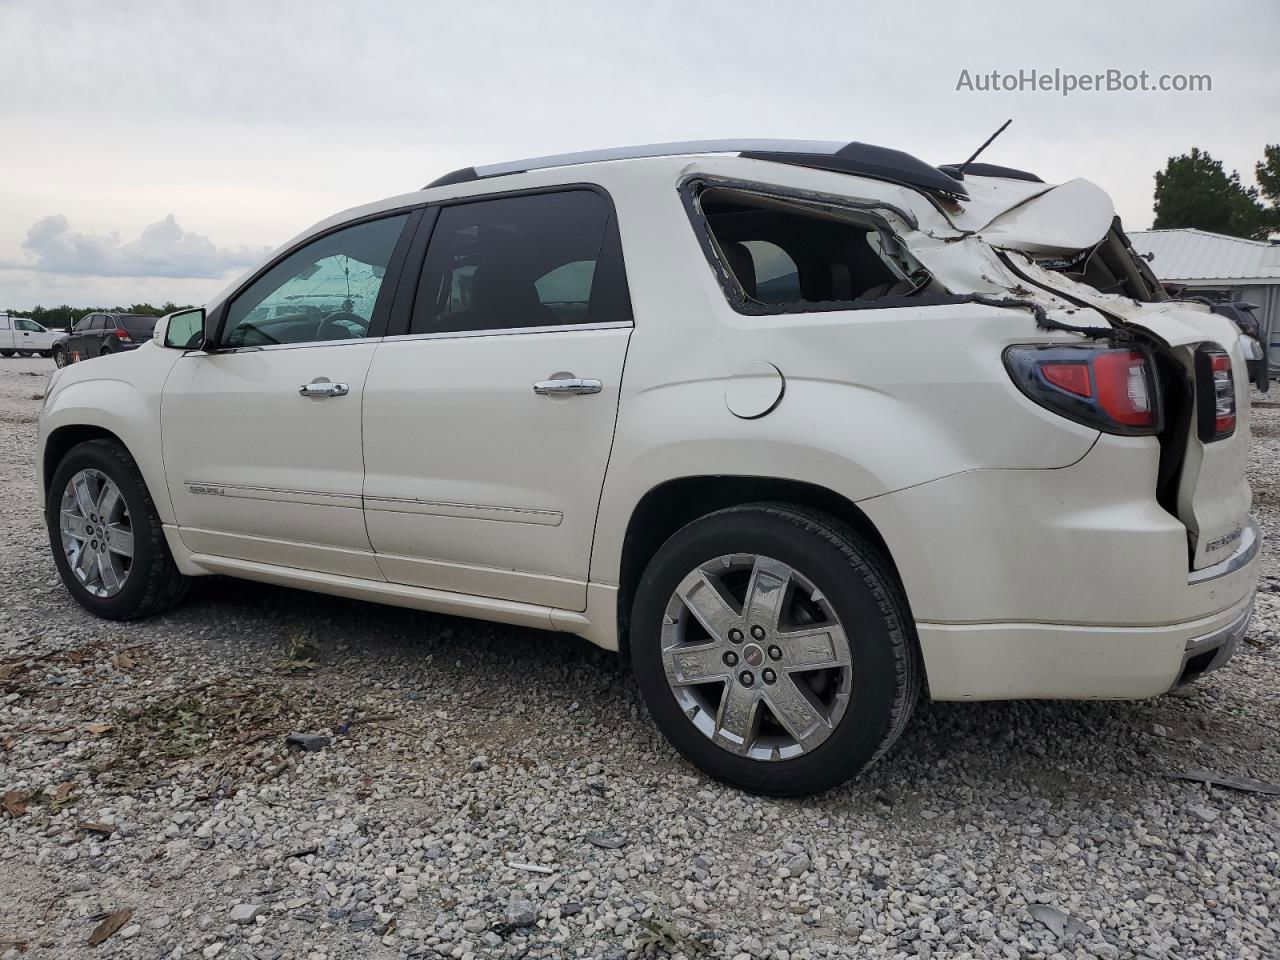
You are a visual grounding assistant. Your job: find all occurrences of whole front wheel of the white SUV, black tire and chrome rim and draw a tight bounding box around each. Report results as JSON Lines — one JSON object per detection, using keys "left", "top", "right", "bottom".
{"left": 47, "top": 440, "right": 188, "bottom": 620}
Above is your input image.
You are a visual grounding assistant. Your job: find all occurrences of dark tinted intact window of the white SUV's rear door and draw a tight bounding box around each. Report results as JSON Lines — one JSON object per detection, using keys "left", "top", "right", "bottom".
{"left": 410, "top": 189, "right": 631, "bottom": 334}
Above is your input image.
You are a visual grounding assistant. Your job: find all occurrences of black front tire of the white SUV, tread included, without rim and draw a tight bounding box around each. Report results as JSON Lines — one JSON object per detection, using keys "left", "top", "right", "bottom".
{"left": 46, "top": 440, "right": 191, "bottom": 620}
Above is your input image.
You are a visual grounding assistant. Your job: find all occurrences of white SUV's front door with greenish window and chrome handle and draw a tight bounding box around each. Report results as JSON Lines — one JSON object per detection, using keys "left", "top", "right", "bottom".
{"left": 161, "top": 214, "right": 408, "bottom": 580}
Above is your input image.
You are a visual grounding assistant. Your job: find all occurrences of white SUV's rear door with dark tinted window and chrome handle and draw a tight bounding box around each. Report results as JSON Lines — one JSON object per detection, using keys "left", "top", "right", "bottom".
{"left": 365, "top": 188, "right": 631, "bottom": 609}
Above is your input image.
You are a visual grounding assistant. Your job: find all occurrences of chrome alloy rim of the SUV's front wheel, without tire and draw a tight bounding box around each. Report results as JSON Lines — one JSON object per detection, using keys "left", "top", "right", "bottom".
{"left": 59, "top": 468, "right": 133, "bottom": 596}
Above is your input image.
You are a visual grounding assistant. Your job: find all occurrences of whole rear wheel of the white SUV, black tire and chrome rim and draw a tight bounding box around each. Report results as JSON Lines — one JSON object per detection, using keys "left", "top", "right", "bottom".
{"left": 631, "top": 503, "right": 922, "bottom": 796}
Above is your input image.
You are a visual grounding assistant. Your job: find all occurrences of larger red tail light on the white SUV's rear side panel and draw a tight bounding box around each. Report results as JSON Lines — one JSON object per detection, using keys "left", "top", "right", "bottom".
{"left": 1005, "top": 344, "right": 1161, "bottom": 435}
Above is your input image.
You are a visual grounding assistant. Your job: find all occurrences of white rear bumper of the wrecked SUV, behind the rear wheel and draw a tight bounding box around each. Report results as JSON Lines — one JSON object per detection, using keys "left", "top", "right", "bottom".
{"left": 860, "top": 438, "right": 1261, "bottom": 700}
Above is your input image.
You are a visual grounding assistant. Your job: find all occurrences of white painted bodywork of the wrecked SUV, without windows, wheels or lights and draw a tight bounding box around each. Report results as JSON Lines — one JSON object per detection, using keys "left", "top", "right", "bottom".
{"left": 41, "top": 156, "right": 1257, "bottom": 699}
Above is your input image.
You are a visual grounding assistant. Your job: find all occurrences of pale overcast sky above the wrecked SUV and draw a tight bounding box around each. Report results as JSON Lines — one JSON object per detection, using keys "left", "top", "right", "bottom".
{"left": 0, "top": 0, "right": 1280, "bottom": 308}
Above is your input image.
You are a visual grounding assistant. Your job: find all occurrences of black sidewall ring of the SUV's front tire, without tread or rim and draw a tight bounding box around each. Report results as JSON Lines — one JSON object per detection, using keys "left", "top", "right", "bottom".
{"left": 45, "top": 440, "right": 160, "bottom": 620}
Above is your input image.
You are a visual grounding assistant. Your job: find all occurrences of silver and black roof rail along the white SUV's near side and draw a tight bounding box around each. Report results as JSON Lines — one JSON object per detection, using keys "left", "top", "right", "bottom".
{"left": 424, "top": 140, "right": 967, "bottom": 197}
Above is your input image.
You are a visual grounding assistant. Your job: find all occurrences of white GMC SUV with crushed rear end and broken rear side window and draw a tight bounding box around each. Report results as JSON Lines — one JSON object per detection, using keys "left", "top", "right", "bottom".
{"left": 38, "top": 141, "right": 1260, "bottom": 794}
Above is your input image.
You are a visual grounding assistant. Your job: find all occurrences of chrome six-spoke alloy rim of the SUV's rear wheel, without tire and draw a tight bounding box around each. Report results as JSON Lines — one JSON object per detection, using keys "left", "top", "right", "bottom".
{"left": 662, "top": 553, "right": 852, "bottom": 760}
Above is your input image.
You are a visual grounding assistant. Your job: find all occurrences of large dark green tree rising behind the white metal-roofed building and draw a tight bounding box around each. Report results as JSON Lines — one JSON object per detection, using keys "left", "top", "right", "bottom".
{"left": 1152, "top": 147, "right": 1272, "bottom": 239}
